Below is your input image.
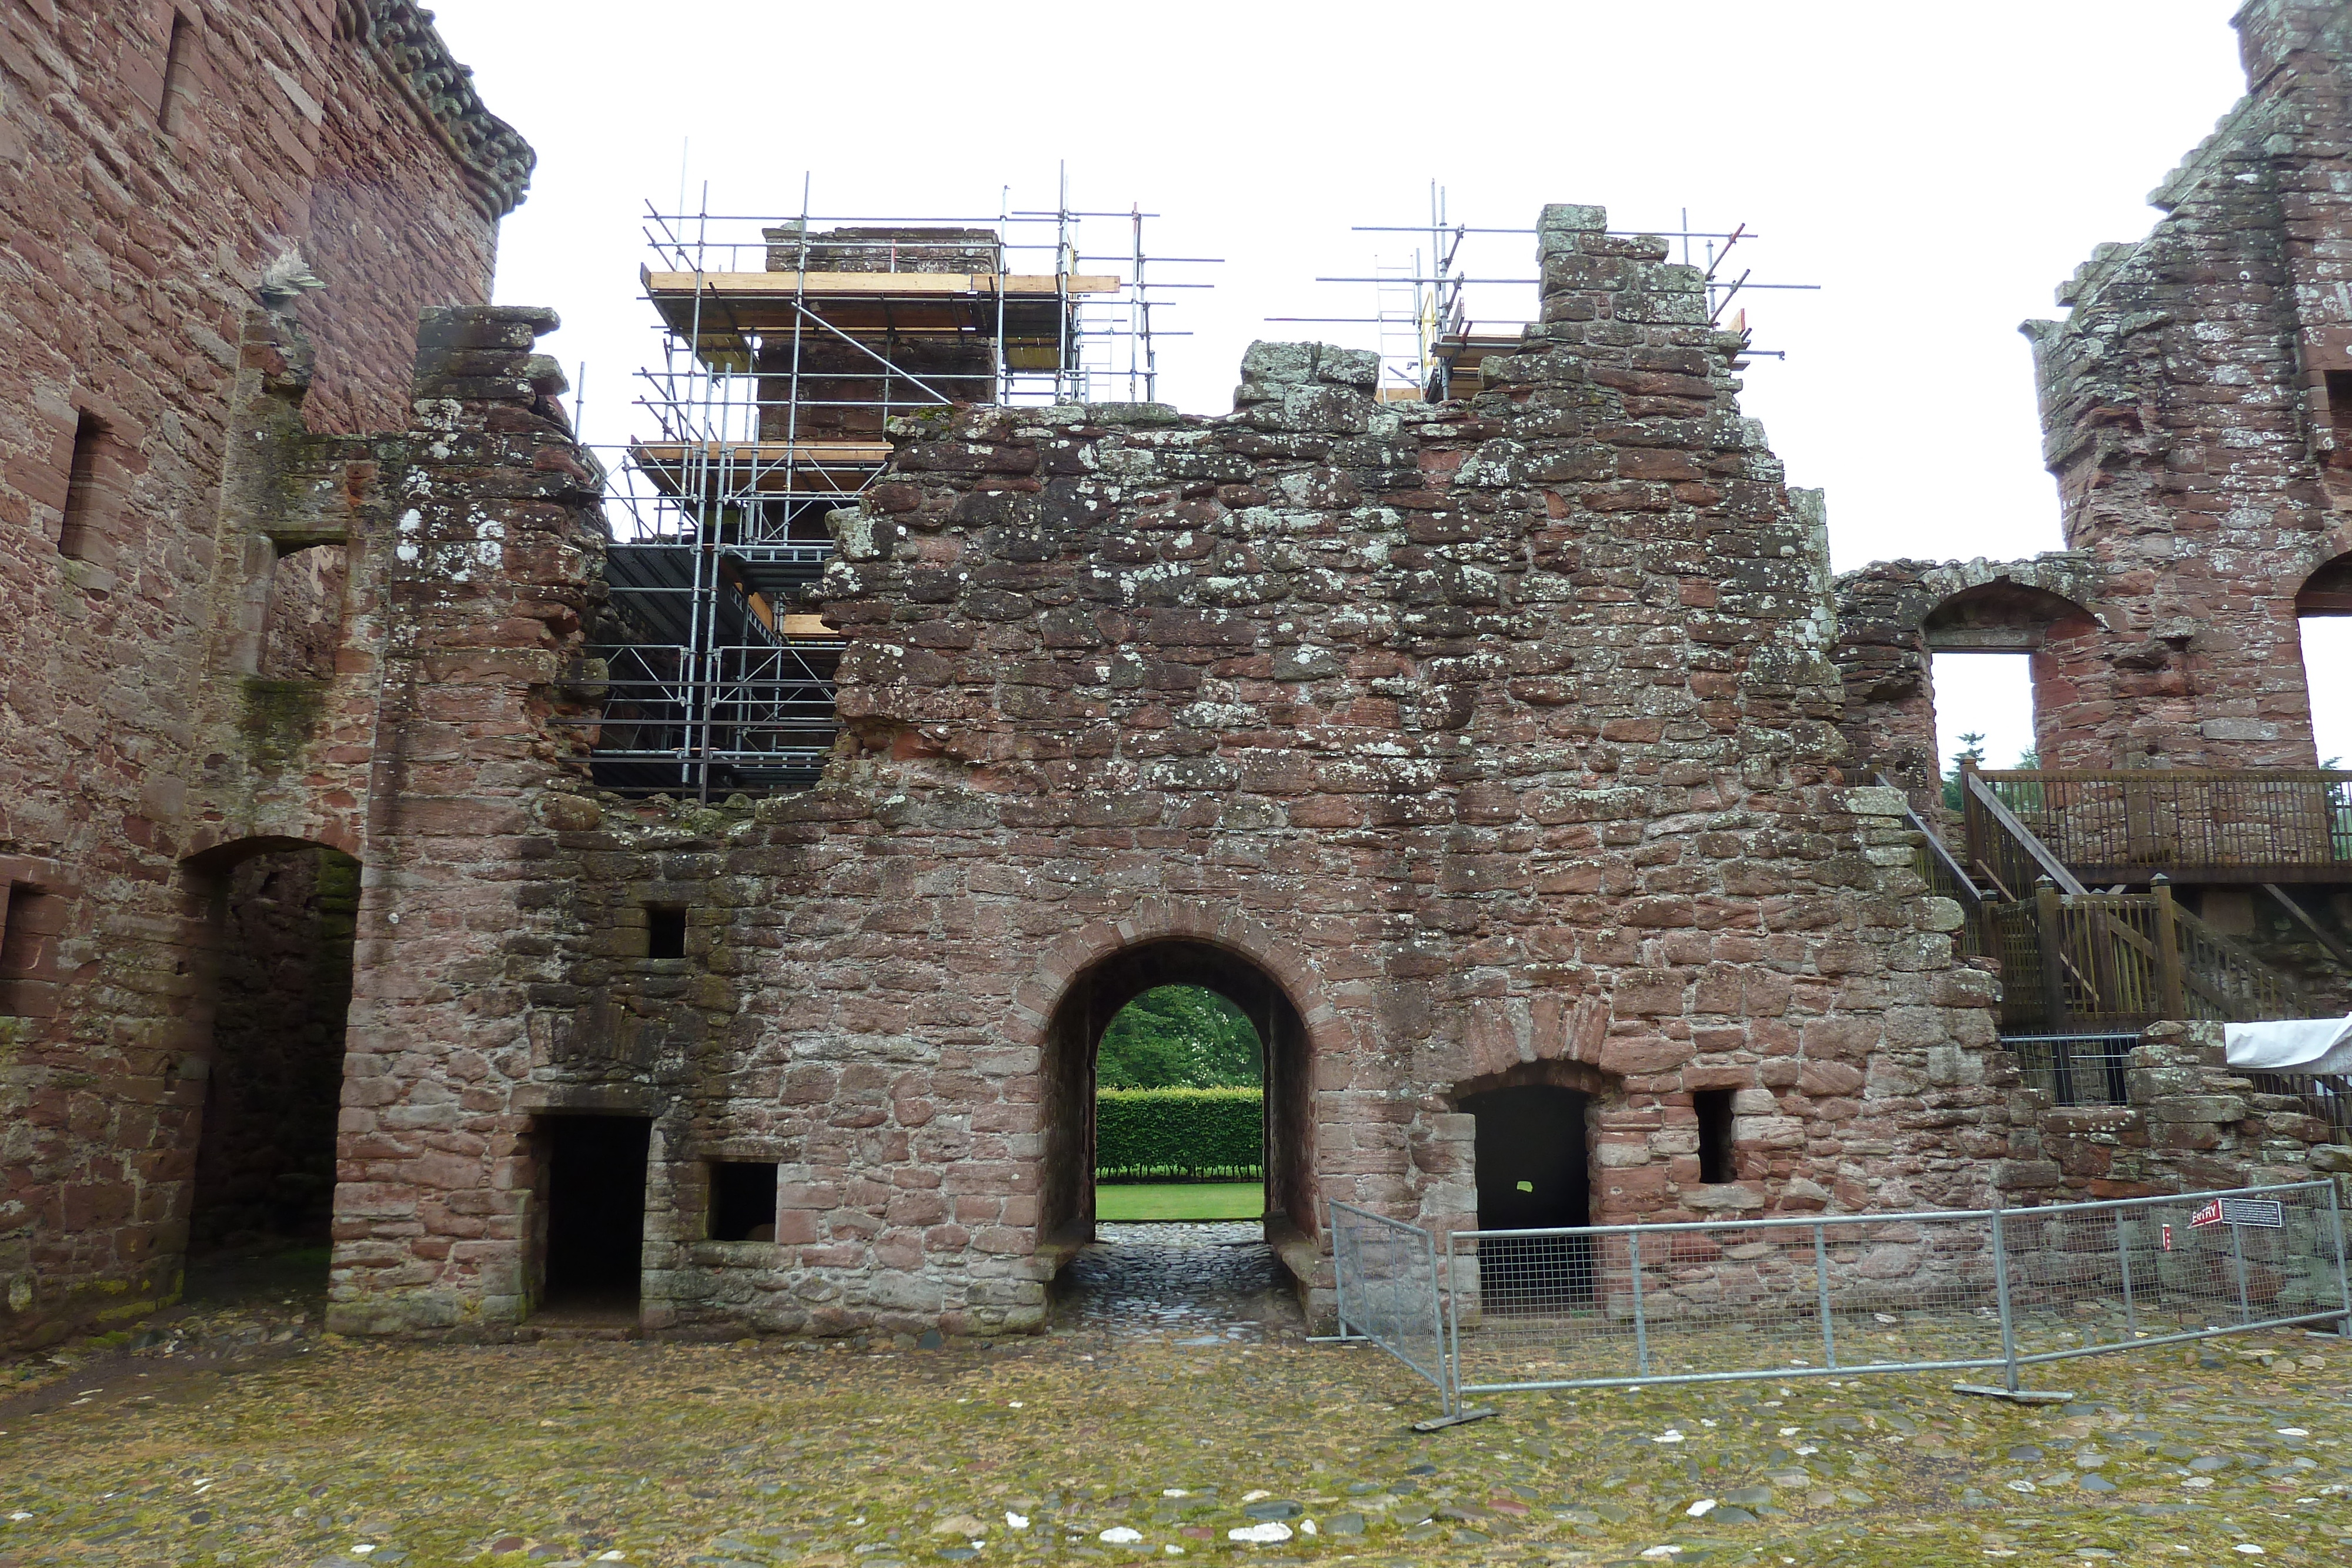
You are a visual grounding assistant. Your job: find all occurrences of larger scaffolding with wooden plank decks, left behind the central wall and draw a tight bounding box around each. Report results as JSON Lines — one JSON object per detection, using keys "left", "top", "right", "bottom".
{"left": 593, "top": 183, "right": 1207, "bottom": 799}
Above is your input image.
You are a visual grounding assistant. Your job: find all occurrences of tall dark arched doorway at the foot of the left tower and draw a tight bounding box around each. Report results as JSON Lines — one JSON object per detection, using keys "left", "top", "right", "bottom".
{"left": 186, "top": 839, "right": 360, "bottom": 1295}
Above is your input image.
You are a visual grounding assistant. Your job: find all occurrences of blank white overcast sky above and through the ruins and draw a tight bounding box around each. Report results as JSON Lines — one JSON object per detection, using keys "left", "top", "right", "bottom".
{"left": 435, "top": 0, "right": 2352, "bottom": 764}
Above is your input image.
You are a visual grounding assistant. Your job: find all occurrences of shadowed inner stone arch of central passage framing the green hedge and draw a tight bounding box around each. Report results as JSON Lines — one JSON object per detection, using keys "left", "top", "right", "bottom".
{"left": 1037, "top": 938, "right": 1317, "bottom": 1274}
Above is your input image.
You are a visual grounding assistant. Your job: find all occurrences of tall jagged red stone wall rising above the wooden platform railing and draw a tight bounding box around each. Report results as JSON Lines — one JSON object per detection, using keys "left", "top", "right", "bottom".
{"left": 2025, "top": 0, "right": 2352, "bottom": 769}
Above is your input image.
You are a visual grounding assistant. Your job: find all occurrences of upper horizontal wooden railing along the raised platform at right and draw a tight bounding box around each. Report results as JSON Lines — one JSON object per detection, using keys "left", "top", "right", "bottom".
{"left": 1962, "top": 769, "right": 2352, "bottom": 895}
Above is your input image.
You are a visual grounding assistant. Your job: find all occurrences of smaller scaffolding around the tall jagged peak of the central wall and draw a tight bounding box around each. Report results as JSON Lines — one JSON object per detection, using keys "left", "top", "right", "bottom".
{"left": 1265, "top": 181, "right": 1820, "bottom": 402}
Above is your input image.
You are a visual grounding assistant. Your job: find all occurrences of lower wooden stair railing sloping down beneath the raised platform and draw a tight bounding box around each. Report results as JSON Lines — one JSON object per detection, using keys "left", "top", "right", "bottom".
{"left": 1987, "top": 879, "right": 2305, "bottom": 1034}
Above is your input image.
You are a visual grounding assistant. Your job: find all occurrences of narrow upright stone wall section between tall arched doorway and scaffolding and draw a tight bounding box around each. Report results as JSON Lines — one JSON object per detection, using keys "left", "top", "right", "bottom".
{"left": 329, "top": 308, "right": 607, "bottom": 1328}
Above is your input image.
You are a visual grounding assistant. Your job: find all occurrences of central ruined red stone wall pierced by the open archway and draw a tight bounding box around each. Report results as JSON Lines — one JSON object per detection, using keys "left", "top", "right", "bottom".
{"left": 372, "top": 207, "right": 2006, "bottom": 1333}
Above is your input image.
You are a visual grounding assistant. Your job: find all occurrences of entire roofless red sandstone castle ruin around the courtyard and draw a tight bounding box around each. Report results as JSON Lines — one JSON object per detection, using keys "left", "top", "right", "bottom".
{"left": 0, "top": 0, "right": 2352, "bottom": 1342}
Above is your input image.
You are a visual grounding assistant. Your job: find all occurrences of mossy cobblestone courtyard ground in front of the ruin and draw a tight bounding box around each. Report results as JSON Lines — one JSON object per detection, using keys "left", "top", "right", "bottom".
{"left": 0, "top": 1227, "right": 2352, "bottom": 1568}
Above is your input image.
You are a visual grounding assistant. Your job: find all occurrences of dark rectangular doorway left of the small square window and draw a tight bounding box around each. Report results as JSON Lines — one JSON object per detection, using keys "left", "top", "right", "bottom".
{"left": 539, "top": 1116, "right": 654, "bottom": 1321}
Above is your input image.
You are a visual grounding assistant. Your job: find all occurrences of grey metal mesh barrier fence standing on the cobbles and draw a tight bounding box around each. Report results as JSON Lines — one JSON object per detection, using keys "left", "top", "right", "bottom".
{"left": 1334, "top": 1180, "right": 2352, "bottom": 1417}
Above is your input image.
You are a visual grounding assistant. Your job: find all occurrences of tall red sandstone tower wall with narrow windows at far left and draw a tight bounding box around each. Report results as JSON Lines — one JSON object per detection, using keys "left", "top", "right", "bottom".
{"left": 0, "top": 0, "right": 527, "bottom": 1342}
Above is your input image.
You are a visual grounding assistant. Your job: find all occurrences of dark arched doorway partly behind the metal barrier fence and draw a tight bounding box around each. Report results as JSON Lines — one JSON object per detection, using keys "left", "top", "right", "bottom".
{"left": 1461, "top": 1084, "right": 1592, "bottom": 1312}
